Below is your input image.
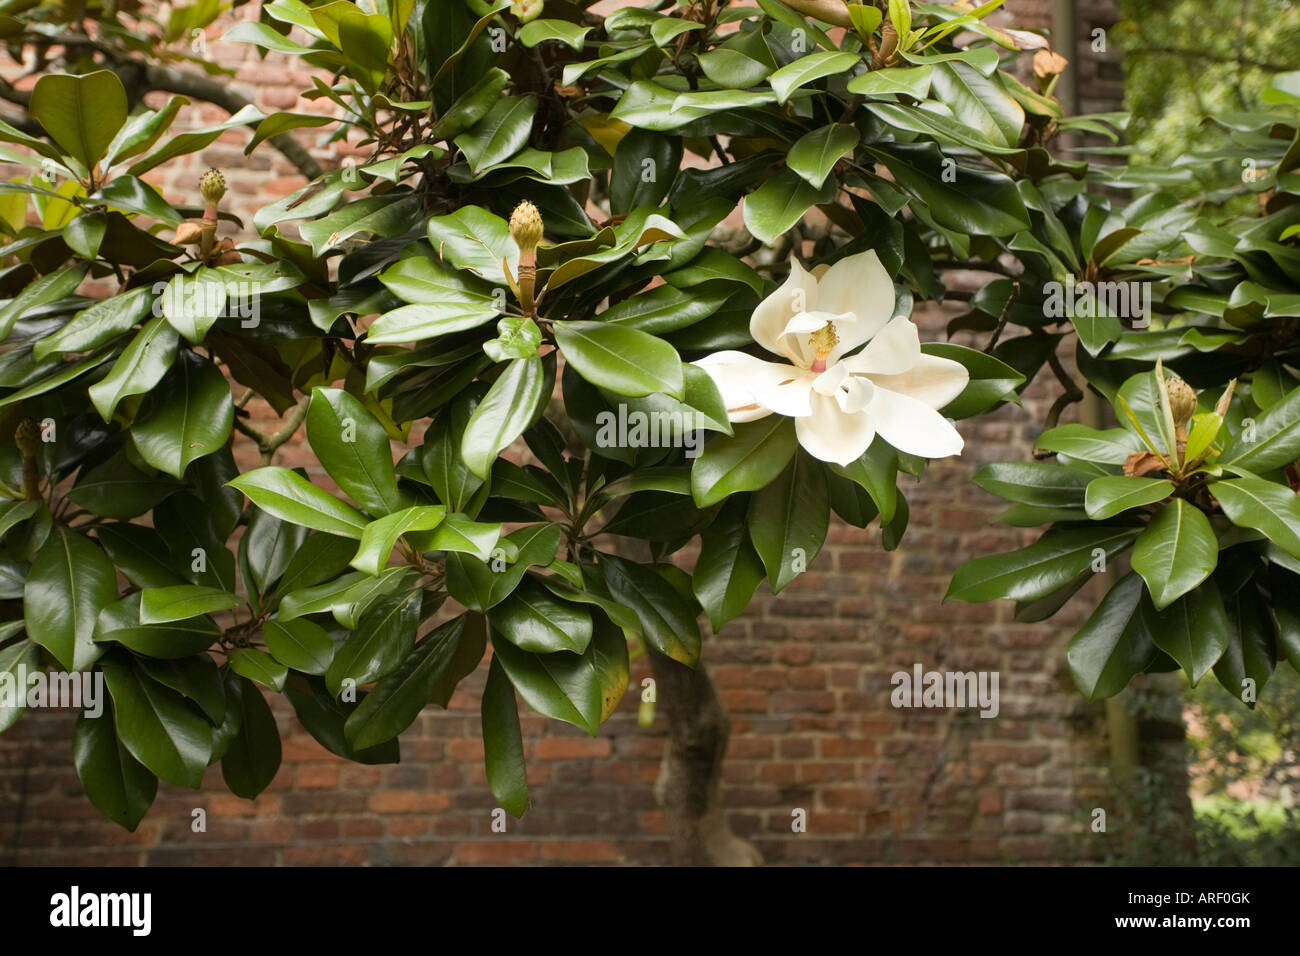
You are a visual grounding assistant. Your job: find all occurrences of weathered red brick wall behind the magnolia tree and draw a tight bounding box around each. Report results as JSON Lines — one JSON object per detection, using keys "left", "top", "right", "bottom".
{"left": 0, "top": 0, "right": 1115, "bottom": 864}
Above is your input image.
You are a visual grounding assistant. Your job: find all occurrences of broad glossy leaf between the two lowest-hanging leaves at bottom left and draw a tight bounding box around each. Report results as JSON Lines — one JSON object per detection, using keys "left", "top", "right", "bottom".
{"left": 100, "top": 654, "right": 212, "bottom": 790}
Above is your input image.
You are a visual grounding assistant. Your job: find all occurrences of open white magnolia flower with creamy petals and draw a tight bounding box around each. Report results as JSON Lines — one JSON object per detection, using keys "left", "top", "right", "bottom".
{"left": 696, "top": 251, "right": 970, "bottom": 464}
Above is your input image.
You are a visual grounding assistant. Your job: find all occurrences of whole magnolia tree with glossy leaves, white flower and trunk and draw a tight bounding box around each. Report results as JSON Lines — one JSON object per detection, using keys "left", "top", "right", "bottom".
{"left": 0, "top": 0, "right": 1300, "bottom": 862}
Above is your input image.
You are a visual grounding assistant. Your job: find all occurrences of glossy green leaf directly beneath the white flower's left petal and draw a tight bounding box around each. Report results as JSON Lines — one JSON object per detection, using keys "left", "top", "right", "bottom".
{"left": 690, "top": 415, "right": 798, "bottom": 507}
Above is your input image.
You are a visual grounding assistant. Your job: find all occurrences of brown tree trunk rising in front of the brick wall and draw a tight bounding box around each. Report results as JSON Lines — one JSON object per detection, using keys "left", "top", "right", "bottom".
{"left": 646, "top": 646, "right": 763, "bottom": 866}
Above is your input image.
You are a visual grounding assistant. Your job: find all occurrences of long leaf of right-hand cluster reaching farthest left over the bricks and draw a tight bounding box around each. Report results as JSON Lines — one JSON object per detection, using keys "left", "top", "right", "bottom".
{"left": 944, "top": 527, "right": 1139, "bottom": 602}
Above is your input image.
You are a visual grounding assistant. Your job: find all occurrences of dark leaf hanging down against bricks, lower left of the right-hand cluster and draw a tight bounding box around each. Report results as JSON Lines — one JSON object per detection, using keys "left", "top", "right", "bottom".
{"left": 1066, "top": 571, "right": 1157, "bottom": 700}
